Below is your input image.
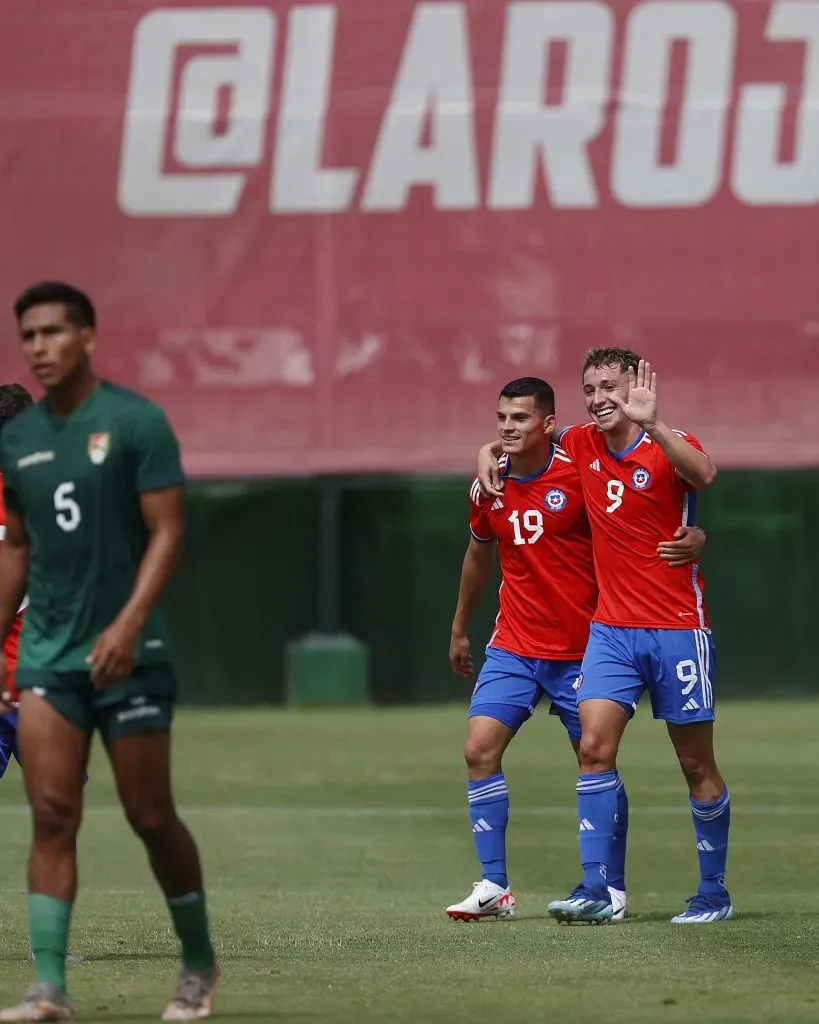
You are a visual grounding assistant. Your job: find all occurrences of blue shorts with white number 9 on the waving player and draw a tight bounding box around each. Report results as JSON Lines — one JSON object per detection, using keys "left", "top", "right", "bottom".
{"left": 577, "top": 623, "right": 717, "bottom": 725}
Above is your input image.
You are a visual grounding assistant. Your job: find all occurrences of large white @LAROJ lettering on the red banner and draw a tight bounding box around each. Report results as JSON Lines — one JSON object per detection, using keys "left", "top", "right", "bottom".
{"left": 118, "top": 0, "right": 819, "bottom": 217}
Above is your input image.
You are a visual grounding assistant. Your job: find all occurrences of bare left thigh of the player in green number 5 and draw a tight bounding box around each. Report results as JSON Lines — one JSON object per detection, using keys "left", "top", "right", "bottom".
{"left": 17, "top": 689, "right": 91, "bottom": 826}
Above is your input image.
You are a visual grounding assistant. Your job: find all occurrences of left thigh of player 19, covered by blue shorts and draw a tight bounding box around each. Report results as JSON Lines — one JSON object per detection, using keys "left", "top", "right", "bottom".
{"left": 469, "top": 647, "right": 543, "bottom": 734}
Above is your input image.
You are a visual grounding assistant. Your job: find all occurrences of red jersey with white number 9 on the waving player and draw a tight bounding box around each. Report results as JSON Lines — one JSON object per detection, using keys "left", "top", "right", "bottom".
{"left": 560, "top": 423, "right": 708, "bottom": 630}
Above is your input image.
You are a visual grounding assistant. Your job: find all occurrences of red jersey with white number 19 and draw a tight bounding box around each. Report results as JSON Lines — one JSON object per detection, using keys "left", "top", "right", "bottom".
{"left": 470, "top": 445, "right": 597, "bottom": 662}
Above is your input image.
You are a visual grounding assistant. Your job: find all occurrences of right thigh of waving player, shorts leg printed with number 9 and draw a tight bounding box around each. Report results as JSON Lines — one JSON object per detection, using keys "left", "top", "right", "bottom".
{"left": 644, "top": 630, "right": 717, "bottom": 732}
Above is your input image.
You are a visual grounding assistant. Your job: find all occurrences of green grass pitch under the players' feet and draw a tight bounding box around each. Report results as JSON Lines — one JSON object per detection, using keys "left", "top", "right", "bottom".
{"left": 0, "top": 702, "right": 819, "bottom": 1024}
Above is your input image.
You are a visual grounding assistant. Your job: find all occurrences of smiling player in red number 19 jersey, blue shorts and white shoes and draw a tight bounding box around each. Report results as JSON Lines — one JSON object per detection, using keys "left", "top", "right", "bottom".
{"left": 446, "top": 377, "right": 704, "bottom": 921}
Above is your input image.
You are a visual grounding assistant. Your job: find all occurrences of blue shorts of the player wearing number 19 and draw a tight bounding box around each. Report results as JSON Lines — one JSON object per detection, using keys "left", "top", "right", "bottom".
{"left": 469, "top": 647, "right": 580, "bottom": 740}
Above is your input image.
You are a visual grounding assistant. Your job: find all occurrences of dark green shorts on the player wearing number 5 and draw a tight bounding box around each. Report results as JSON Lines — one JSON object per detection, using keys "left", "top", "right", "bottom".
{"left": 15, "top": 664, "right": 177, "bottom": 746}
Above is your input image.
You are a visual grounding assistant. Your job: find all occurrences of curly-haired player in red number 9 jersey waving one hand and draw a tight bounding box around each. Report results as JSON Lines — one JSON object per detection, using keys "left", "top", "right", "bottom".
{"left": 479, "top": 348, "right": 733, "bottom": 925}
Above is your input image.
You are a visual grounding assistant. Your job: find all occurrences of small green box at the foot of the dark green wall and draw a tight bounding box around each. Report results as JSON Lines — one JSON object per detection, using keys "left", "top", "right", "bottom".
{"left": 285, "top": 633, "right": 370, "bottom": 708}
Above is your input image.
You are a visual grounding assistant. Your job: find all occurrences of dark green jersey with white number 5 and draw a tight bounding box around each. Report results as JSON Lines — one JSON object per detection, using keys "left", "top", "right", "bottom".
{"left": 0, "top": 381, "right": 184, "bottom": 673}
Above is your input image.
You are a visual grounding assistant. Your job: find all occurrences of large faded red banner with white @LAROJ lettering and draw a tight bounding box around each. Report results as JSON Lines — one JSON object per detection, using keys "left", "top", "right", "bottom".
{"left": 0, "top": 0, "right": 819, "bottom": 475}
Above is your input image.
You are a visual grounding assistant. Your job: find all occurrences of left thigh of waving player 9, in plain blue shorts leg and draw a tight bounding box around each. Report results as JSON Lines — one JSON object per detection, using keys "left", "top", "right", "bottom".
{"left": 576, "top": 623, "right": 646, "bottom": 721}
